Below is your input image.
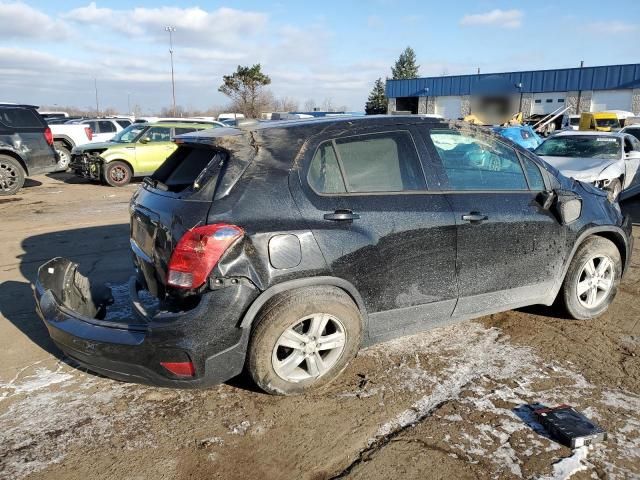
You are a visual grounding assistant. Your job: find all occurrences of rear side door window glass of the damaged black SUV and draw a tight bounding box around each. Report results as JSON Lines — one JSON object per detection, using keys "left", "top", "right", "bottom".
{"left": 307, "top": 131, "right": 427, "bottom": 194}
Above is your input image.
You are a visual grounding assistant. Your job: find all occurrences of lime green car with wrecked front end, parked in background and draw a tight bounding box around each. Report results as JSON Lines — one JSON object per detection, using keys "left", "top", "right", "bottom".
{"left": 69, "top": 122, "right": 214, "bottom": 187}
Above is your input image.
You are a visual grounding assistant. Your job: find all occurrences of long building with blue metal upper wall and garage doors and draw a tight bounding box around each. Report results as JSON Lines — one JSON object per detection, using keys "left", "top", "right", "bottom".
{"left": 386, "top": 64, "right": 640, "bottom": 118}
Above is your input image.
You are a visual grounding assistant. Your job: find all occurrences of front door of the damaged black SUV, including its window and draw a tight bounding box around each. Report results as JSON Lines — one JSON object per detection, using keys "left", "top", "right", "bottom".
{"left": 427, "top": 128, "right": 566, "bottom": 317}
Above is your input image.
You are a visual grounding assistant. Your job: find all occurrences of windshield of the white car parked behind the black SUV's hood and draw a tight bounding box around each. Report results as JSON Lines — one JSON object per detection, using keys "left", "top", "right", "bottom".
{"left": 535, "top": 135, "right": 621, "bottom": 160}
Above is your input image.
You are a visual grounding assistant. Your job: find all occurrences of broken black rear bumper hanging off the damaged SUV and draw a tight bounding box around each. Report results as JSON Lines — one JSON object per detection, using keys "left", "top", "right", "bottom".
{"left": 35, "top": 258, "right": 258, "bottom": 388}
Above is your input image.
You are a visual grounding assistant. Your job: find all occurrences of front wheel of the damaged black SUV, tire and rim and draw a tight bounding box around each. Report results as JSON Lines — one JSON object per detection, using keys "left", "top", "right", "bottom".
{"left": 561, "top": 236, "right": 622, "bottom": 320}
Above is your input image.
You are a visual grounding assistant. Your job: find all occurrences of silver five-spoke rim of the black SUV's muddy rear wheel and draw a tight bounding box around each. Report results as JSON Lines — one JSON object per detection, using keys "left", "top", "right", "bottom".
{"left": 271, "top": 313, "right": 347, "bottom": 383}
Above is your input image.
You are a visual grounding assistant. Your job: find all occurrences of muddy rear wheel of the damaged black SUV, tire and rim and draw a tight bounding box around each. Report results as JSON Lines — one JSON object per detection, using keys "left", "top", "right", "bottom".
{"left": 247, "top": 286, "right": 362, "bottom": 395}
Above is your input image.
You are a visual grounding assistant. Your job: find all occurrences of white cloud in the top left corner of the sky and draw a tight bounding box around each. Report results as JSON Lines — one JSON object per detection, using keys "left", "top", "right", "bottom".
{"left": 0, "top": 2, "right": 68, "bottom": 40}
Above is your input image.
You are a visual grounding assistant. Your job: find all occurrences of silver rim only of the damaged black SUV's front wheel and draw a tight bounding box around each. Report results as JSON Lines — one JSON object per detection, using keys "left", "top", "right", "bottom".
{"left": 576, "top": 255, "right": 615, "bottom": 309}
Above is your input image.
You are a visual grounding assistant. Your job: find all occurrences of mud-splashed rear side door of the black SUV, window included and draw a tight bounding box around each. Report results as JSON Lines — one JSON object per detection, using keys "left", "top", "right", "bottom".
{"left": 290, "top": 126, "right": 457, "bottom": 341}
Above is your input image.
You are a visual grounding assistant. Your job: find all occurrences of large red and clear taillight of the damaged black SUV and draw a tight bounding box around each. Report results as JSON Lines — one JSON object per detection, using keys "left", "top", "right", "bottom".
{"left": 167, "top": 223, "right": 244, "bottom": 288}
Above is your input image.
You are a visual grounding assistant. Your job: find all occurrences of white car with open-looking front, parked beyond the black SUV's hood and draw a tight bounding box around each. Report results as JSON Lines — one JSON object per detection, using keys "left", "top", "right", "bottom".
{"left": 534, "top": 131, "right": 640, "bottom": 199}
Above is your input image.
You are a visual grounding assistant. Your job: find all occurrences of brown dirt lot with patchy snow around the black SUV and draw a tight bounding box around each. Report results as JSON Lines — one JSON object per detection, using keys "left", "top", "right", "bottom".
{"left": 0, "top": 175, "right": 640, "bottom": 480}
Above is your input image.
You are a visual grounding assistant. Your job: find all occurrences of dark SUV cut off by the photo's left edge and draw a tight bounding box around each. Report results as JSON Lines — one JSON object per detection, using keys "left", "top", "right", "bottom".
{"left": 0, "top": 103, "right": 58, "bottom": 195}
